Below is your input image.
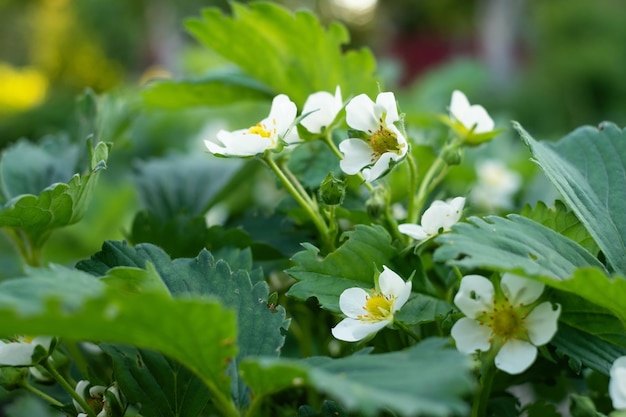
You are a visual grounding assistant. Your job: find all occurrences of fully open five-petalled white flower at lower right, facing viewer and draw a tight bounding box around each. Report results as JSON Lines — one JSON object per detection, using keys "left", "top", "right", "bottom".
{"left": 451, "top": 273, "right": 561, "bottom": 374}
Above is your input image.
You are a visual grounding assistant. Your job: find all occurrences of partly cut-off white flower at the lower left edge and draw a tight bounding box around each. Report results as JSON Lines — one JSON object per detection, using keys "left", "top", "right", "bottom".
{"left": 0, "top": 336, "right": 52, "bottom": 366}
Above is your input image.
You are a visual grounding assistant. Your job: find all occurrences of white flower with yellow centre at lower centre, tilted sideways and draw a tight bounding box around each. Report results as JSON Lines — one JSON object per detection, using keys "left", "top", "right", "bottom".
{"left": 332, "top": 266, "right": 411, "bottom": 342}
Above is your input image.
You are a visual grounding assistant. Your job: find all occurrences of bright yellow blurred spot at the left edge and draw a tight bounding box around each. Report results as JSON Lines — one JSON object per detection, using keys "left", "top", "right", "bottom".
{"left": 0, "top": 62, "right": 48, "bottom": 113}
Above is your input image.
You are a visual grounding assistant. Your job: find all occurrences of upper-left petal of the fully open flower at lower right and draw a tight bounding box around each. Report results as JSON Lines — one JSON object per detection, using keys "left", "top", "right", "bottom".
{"left": 454, "top": 275, "right": 495, "bottom": 319}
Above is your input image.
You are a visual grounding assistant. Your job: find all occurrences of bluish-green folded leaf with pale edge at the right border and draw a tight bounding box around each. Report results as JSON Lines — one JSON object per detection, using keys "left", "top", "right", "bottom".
{"left": 513, "top": 123, "right": 626, "bottom": 274}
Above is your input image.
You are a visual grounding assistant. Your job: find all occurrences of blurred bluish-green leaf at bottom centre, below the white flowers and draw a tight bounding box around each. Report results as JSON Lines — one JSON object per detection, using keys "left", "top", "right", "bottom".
{"left": 242, "top": 338, "right": 474, "bottom": 416}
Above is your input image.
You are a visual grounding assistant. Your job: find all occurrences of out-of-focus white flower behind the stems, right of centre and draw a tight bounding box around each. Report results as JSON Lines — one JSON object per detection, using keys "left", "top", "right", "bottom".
{"left": 470, "top": 159, "right": 522, "bottom": 210}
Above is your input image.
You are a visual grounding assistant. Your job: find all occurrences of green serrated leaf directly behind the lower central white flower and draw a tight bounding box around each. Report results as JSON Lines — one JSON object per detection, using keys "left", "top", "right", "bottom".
{"left": 285, "top": 225, "right": 396, "bottom": 312}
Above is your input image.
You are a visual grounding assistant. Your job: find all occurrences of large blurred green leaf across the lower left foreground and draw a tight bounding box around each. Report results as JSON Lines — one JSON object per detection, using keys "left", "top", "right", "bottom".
{"left": 0, "top": 267, "right": 236, "bottom": 413}
